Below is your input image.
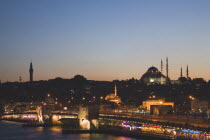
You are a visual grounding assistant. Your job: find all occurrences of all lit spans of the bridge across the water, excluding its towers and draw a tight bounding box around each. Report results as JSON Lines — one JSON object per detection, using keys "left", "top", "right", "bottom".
{"left": 2, "top": 113, "right": 210, "bottom": 140}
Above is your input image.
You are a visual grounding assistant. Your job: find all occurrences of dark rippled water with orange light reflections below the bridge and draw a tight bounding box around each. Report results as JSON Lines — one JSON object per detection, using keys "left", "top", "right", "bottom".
{"left": 0, "top": 121, "right": 140, "bottom": 140}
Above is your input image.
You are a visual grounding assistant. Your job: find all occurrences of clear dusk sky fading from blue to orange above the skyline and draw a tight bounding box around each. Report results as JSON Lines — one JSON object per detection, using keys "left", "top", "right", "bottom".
{"left": 0, "top": 0, "right": 210, "bottom": 82}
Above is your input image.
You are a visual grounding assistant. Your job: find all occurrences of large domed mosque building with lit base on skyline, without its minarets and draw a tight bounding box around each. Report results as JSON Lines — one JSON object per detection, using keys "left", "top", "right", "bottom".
{"left": 140, "top": 66, "right": 169, "bottom": 85}
